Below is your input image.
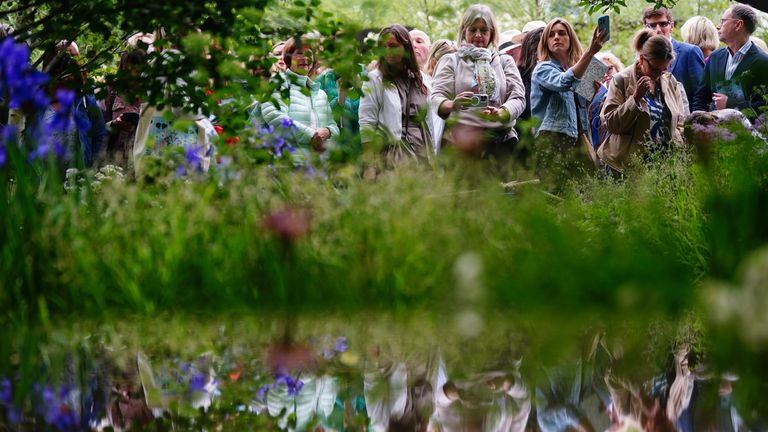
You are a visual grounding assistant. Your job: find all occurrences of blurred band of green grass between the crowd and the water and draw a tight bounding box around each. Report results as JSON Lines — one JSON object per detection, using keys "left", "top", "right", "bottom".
{"left": 0, "top": 124, "right": 766, "bottom": 418}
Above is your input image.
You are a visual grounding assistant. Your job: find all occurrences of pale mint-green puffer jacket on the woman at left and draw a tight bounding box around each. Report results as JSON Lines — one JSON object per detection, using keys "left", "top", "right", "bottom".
{"left": 261, "top": 70, "right": 339, "bottom": 149}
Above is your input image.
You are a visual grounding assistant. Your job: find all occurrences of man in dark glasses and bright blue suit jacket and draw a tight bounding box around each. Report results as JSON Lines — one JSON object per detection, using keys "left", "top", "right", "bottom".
{"left": 643, "top": 6, "right": 704, "bottom": 106}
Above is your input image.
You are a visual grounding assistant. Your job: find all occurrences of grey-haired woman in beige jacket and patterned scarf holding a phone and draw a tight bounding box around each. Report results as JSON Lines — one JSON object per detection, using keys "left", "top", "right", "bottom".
{"left": 431, "top": 4, "right": 525, "bottom": 156}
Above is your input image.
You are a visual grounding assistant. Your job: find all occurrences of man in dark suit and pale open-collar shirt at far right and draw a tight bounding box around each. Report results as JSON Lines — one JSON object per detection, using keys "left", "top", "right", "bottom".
{"left": 693, "top": 4, "right": 768, "bottom": 117}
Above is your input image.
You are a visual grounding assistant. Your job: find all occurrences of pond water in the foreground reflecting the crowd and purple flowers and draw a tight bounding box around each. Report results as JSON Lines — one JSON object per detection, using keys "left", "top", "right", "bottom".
{"left": 0, "top": 313, "right": 764, "bottom": 431}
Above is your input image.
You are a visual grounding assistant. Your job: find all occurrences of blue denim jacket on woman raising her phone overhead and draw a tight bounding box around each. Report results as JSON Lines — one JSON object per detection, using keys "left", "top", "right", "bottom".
{"left": 531, "top": 58, "right": 589, "bottom": 138}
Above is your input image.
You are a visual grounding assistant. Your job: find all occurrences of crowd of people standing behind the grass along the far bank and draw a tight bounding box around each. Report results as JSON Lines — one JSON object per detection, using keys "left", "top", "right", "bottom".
{"left": 4, "top": 4, "right": 768, "bottom": 188}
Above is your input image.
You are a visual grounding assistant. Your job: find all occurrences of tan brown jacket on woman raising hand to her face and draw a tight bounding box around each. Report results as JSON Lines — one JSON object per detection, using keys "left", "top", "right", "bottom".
{"left": 597, "top": 64, "right": 685, "bottom": 172}
